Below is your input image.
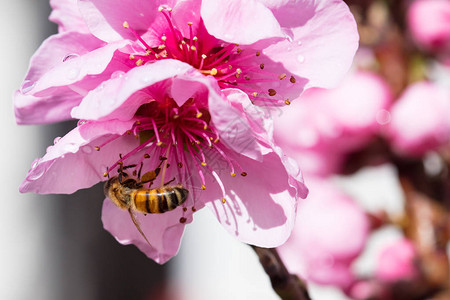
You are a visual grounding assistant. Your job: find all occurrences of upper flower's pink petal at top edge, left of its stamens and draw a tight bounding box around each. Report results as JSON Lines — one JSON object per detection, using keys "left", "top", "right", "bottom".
{"left": 78, "top": 0, "right": 175, "bottom": 42}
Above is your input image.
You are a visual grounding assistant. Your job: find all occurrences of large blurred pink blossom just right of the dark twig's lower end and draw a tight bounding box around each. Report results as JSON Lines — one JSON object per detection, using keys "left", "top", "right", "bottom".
{"left": 278, "top": 178, "right": 369, "bottom": 288}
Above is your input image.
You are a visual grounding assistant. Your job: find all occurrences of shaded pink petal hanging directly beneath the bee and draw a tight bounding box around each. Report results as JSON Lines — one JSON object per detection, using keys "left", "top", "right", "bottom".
{"left": 102, "top": 199, "right": 198, "bottom": 264}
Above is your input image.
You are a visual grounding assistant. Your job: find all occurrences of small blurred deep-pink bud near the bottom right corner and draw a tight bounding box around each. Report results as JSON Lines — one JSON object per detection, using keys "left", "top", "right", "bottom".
{"left": 375, "top": 239, "right": 417, "bottom": 282}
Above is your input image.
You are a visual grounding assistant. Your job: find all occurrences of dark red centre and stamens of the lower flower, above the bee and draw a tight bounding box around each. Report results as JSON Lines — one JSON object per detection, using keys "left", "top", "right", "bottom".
{"left": 95, "top": 98, "right": 247, "bottom": 209}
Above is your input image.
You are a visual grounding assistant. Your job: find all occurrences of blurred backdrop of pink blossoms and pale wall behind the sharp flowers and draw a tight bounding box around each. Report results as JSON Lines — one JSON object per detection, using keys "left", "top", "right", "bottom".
{"left": 0, "top": 0, "right": 450, "bottom": 300}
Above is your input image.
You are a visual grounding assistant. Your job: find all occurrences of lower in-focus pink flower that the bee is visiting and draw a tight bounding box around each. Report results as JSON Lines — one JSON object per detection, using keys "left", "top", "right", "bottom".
{"left": 20, "top": 60, "right": 307, "bottom": 263}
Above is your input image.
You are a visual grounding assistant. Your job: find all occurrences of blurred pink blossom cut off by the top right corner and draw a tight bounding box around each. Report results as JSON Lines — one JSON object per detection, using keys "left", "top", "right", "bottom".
{"left": 407, "top": 0, "right": 450, "bottom": 54}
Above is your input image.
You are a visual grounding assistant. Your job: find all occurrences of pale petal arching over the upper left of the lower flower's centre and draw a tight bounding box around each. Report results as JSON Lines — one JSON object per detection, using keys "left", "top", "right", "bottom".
{"left": 72, "top": 59, "right": 193, "bottom": 120}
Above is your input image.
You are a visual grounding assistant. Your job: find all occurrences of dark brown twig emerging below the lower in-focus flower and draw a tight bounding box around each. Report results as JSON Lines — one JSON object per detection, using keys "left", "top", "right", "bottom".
{"left": 251, "top": 246, "right": 311, "bottom": 300}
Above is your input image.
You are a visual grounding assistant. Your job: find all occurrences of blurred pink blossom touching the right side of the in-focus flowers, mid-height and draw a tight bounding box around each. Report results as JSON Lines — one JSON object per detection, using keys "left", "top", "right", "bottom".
{"left": 275, "top": 71, "right": 392, "bottom": 175}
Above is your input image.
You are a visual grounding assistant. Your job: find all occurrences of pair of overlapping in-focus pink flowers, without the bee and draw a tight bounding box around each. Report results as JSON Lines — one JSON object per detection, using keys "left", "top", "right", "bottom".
{"left": 15, "top": 0, "right": 358, "bottom": 263}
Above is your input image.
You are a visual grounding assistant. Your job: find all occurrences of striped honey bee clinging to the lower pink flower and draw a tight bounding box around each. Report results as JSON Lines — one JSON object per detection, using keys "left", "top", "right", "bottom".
{"left": 103, "top": 158, "right": 189, "bottom": 246}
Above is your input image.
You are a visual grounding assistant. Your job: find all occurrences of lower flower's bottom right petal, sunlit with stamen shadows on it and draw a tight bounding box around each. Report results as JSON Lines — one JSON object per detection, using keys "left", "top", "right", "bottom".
{"left": 203, "top": 153, "right": 302, "bottom": 247}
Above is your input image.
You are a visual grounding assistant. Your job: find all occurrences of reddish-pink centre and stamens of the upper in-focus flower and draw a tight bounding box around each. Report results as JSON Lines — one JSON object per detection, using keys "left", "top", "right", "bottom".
{"left": 123, "top": 7, "right": 296, "bottom": 105}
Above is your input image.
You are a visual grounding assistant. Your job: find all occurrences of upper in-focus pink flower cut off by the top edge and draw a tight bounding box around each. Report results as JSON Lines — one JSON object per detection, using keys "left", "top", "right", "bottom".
{"left": 15, "top": 0, "right": 358, "bottom": 123}
